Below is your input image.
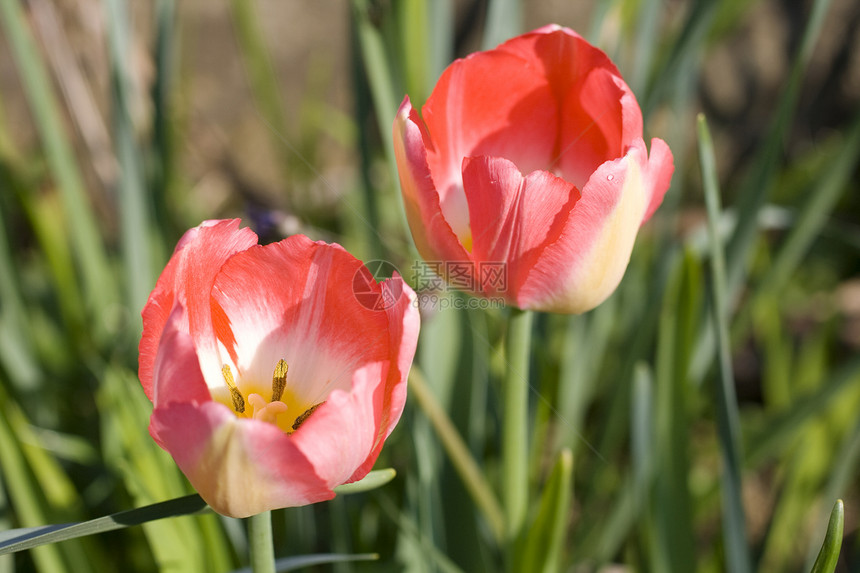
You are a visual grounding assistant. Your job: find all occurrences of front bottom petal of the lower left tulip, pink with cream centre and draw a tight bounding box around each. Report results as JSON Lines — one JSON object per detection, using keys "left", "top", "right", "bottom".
{"left": 150, "top": 402, "right": 334, "bottom": 517}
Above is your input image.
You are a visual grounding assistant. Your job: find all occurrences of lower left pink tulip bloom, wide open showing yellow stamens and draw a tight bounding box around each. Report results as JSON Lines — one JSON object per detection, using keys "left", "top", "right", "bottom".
{"left": 140, "top": 220, "right": 419, "bottom": 517}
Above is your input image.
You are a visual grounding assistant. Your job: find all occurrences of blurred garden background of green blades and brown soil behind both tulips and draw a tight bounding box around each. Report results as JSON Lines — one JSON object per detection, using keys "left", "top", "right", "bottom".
{"left": 0, "top": 0, "right": 860, "bottom": 572}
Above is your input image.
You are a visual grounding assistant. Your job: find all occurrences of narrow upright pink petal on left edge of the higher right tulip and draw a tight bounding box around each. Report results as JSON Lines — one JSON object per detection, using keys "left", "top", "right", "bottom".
{"left": 394, "top": 97, "right": 469, "bottom": 261}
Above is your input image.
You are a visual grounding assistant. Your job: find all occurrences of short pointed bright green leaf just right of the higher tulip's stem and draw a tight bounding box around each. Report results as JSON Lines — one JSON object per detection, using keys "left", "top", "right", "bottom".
{"left": 517, "top": 448, "right": 573, "bottom": 573}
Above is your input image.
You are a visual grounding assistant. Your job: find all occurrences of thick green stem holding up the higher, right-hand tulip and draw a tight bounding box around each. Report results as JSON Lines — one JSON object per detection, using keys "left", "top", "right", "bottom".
{"left": 502, "top": 308, "right": 533, "bottom": 541}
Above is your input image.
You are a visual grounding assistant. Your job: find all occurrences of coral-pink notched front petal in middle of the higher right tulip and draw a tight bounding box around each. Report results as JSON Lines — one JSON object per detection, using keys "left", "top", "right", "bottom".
{"left": 463, "top": 157, "right": 579, "bottom": 304}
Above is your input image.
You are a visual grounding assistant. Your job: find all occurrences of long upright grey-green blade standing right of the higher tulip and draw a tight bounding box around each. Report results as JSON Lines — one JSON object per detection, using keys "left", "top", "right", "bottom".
{"left": 698, "top": 115, "right": 751, "bottom": 573}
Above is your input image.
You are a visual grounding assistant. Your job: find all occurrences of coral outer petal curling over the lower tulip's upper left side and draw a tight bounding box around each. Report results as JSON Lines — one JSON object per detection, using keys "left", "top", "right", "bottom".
{"left": 139, "top": 219, "right": 257, "bottom": 399}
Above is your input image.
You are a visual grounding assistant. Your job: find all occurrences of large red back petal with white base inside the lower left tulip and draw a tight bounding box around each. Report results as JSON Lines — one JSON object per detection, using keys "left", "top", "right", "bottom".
{"left": 212, "top": 235, "right": 400, "bottom": 418}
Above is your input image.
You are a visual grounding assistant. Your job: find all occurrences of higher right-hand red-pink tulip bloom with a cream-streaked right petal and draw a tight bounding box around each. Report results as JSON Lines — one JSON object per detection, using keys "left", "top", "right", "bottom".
{"left": 394, "top": 25, "right": 674, "bottom": 313}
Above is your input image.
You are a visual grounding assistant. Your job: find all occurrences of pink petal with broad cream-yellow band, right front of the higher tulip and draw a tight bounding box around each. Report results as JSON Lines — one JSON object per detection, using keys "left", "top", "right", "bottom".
{"left": 520, "top": 146, "right": 651, "bottom": 313}
